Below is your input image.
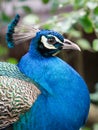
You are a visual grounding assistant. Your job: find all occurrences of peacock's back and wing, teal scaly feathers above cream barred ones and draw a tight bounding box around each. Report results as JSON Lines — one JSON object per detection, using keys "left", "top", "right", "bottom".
{"left": 0, "top": 62, "right": 40, "bottom": 129}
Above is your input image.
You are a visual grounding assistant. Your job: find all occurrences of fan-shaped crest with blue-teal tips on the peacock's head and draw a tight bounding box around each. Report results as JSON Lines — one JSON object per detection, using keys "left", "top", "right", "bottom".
{"left": 6, "top": 14, "right": 40, "bottom": 48}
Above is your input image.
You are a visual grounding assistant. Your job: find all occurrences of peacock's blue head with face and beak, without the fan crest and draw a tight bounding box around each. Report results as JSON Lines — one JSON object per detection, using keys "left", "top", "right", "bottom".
{"left": 35, "top": 30, "right": 80, "bottom": 57}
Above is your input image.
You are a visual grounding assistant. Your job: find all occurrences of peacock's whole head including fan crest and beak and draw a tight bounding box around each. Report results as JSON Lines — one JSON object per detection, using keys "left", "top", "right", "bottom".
{"left": 6, "top": 15, "right": 80, "bottom": 57}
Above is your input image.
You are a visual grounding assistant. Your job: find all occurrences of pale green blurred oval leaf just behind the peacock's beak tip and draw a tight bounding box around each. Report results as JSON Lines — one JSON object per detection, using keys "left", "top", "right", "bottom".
{"left": 77, "top": 39, "right": 91, "bottom": 50}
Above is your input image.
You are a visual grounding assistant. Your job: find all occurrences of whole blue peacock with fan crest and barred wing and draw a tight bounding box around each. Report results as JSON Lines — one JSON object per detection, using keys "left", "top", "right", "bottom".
{"left": 0, "top": 14, "right": 90, "bottom": 130}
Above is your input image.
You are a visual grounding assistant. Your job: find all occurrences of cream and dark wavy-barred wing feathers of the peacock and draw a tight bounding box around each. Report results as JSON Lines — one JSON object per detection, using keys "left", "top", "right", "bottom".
{"left": 0, "top": 76, "right": 40, "bottom": 129}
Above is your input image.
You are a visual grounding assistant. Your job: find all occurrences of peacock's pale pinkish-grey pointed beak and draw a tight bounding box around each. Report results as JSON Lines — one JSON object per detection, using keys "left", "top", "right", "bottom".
{"left": 63, "top": 39, "right": 81, "bottom": 51}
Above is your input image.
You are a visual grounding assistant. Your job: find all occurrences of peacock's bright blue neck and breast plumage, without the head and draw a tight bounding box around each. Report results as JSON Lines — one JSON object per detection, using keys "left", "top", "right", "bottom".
{"left": 14, "top": 38, "right": 90, "bottom": 130}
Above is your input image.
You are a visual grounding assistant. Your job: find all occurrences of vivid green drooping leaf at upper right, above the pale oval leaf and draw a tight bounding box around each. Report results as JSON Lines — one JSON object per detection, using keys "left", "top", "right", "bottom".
{"left": 79, "top": 15, "right": 93, "bottom": 33}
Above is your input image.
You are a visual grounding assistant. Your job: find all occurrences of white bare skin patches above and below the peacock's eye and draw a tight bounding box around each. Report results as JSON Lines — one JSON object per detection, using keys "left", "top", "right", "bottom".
{"left": 41, "top": 35, "right": 62, "bottom": 49}
